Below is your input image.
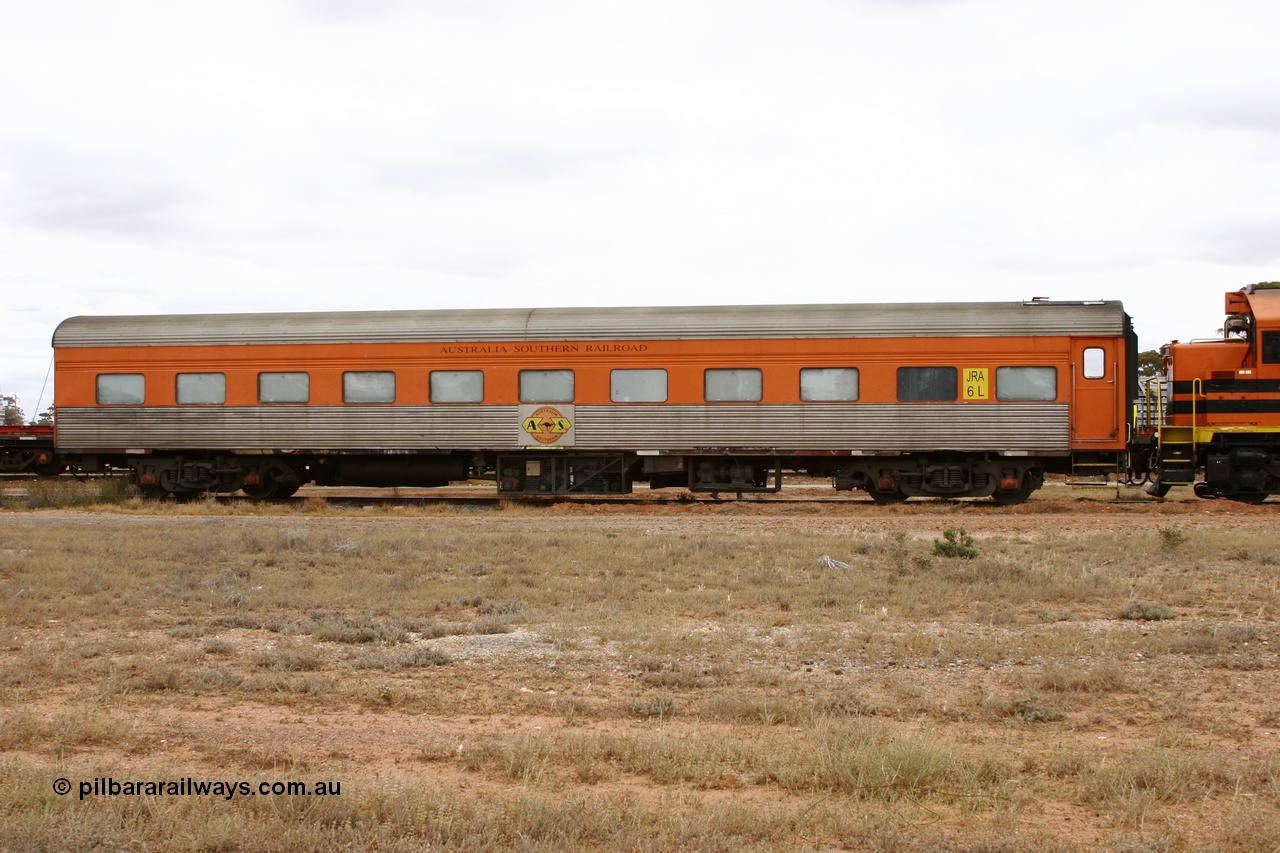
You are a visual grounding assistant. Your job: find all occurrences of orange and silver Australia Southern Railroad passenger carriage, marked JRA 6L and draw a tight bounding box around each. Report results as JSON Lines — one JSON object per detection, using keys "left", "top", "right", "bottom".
{"left": 47, "top": 301, "right": 1135, "bottom": 496}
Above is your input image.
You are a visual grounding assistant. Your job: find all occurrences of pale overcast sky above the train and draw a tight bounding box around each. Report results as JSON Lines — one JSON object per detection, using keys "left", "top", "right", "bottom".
{"left": 0, "top": 0, "right": 1280, "bottom": 415}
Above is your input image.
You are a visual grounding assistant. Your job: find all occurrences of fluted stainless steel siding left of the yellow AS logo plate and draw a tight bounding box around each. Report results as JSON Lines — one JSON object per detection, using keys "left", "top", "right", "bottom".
{"left": 58, "top": 406, "right": 520, "bottom": 451}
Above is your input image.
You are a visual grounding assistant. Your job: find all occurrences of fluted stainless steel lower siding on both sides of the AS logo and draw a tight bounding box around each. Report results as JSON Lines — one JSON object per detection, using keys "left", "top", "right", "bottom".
{"left": 58, "top": 403, "right": 1069, "bottom": 453}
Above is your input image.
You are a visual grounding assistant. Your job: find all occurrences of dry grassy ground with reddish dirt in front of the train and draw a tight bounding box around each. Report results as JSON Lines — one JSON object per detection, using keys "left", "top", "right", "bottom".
{"left": 0, "top": 500, "right": 1280, "bottom": 852}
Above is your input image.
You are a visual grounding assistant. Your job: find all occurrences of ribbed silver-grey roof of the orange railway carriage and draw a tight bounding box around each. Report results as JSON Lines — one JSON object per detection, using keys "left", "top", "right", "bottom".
{"left": 54, "top": 300, "right": 1126, "bottom": 347}
